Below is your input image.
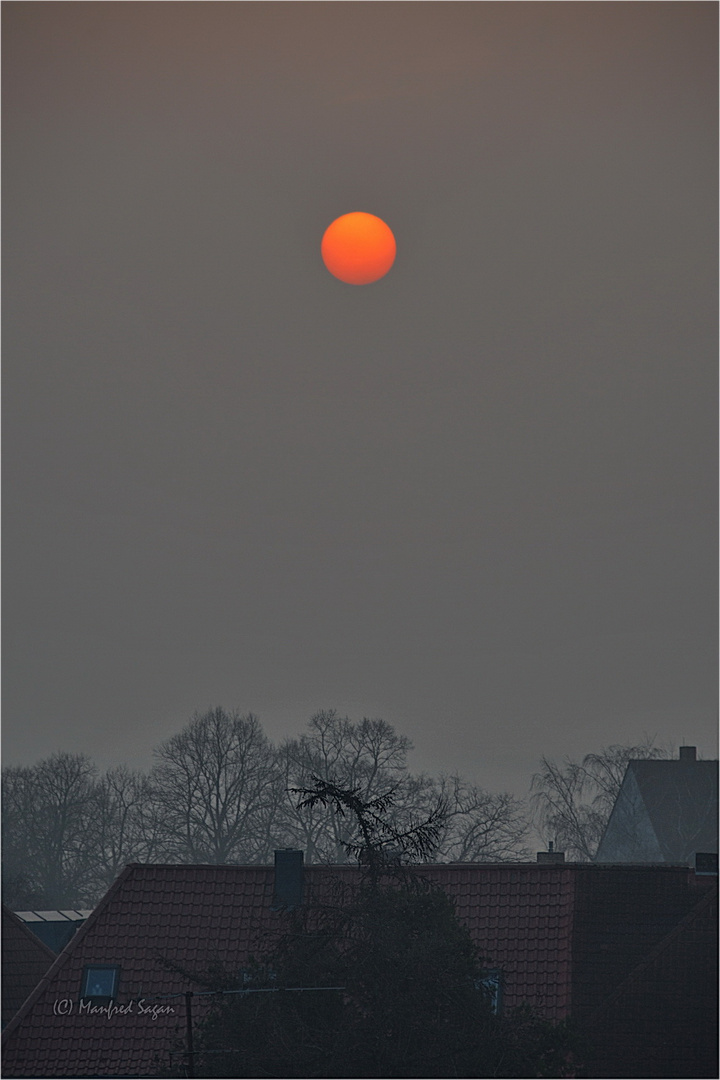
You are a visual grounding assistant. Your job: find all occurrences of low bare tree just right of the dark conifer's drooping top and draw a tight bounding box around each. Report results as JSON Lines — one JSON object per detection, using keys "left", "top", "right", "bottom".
{"left": 436, "top": 773, "right": 530, "bottom": 863}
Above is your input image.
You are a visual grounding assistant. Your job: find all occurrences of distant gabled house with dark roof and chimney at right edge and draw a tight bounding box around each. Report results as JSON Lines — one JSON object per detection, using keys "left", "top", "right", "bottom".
{"left": 595, "top": 746, "right": 718, "bottom": 865}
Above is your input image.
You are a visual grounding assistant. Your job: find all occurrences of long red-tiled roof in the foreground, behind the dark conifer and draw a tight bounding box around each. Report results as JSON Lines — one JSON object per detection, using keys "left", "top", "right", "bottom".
{"left": 3, "top": 863, "right": 716, "bottom": 1077}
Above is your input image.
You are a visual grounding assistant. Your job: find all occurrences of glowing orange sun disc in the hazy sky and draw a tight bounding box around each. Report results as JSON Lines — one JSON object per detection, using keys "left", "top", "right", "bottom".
{"left": 321, "top": 212, "right": 396, "bottom": 285}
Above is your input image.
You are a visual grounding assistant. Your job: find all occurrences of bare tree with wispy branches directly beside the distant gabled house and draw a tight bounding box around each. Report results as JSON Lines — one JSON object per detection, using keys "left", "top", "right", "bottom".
{"left": 531, "top": 739, "right": 670, "bottom": 862}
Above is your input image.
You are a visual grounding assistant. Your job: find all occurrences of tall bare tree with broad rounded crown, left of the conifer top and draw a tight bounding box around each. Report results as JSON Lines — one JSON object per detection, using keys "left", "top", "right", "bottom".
{"left": 150, "top": 708, "right": 283, "bottom": 863}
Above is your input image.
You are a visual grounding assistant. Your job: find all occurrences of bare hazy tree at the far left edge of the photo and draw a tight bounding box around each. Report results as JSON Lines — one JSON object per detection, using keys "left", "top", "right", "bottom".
{"left": 2, "top": 753, "right": 97, "bottom": 908}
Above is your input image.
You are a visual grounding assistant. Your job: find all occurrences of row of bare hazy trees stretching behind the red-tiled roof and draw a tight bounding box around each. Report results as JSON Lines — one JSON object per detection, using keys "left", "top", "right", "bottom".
{"left": 2, "top": 707, "right": 665, "bottom": 910}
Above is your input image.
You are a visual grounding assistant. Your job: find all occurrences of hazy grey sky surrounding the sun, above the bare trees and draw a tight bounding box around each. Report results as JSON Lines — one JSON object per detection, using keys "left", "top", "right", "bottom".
{"left": 3, "top": 2, "right": 718, "bottom": 794}
